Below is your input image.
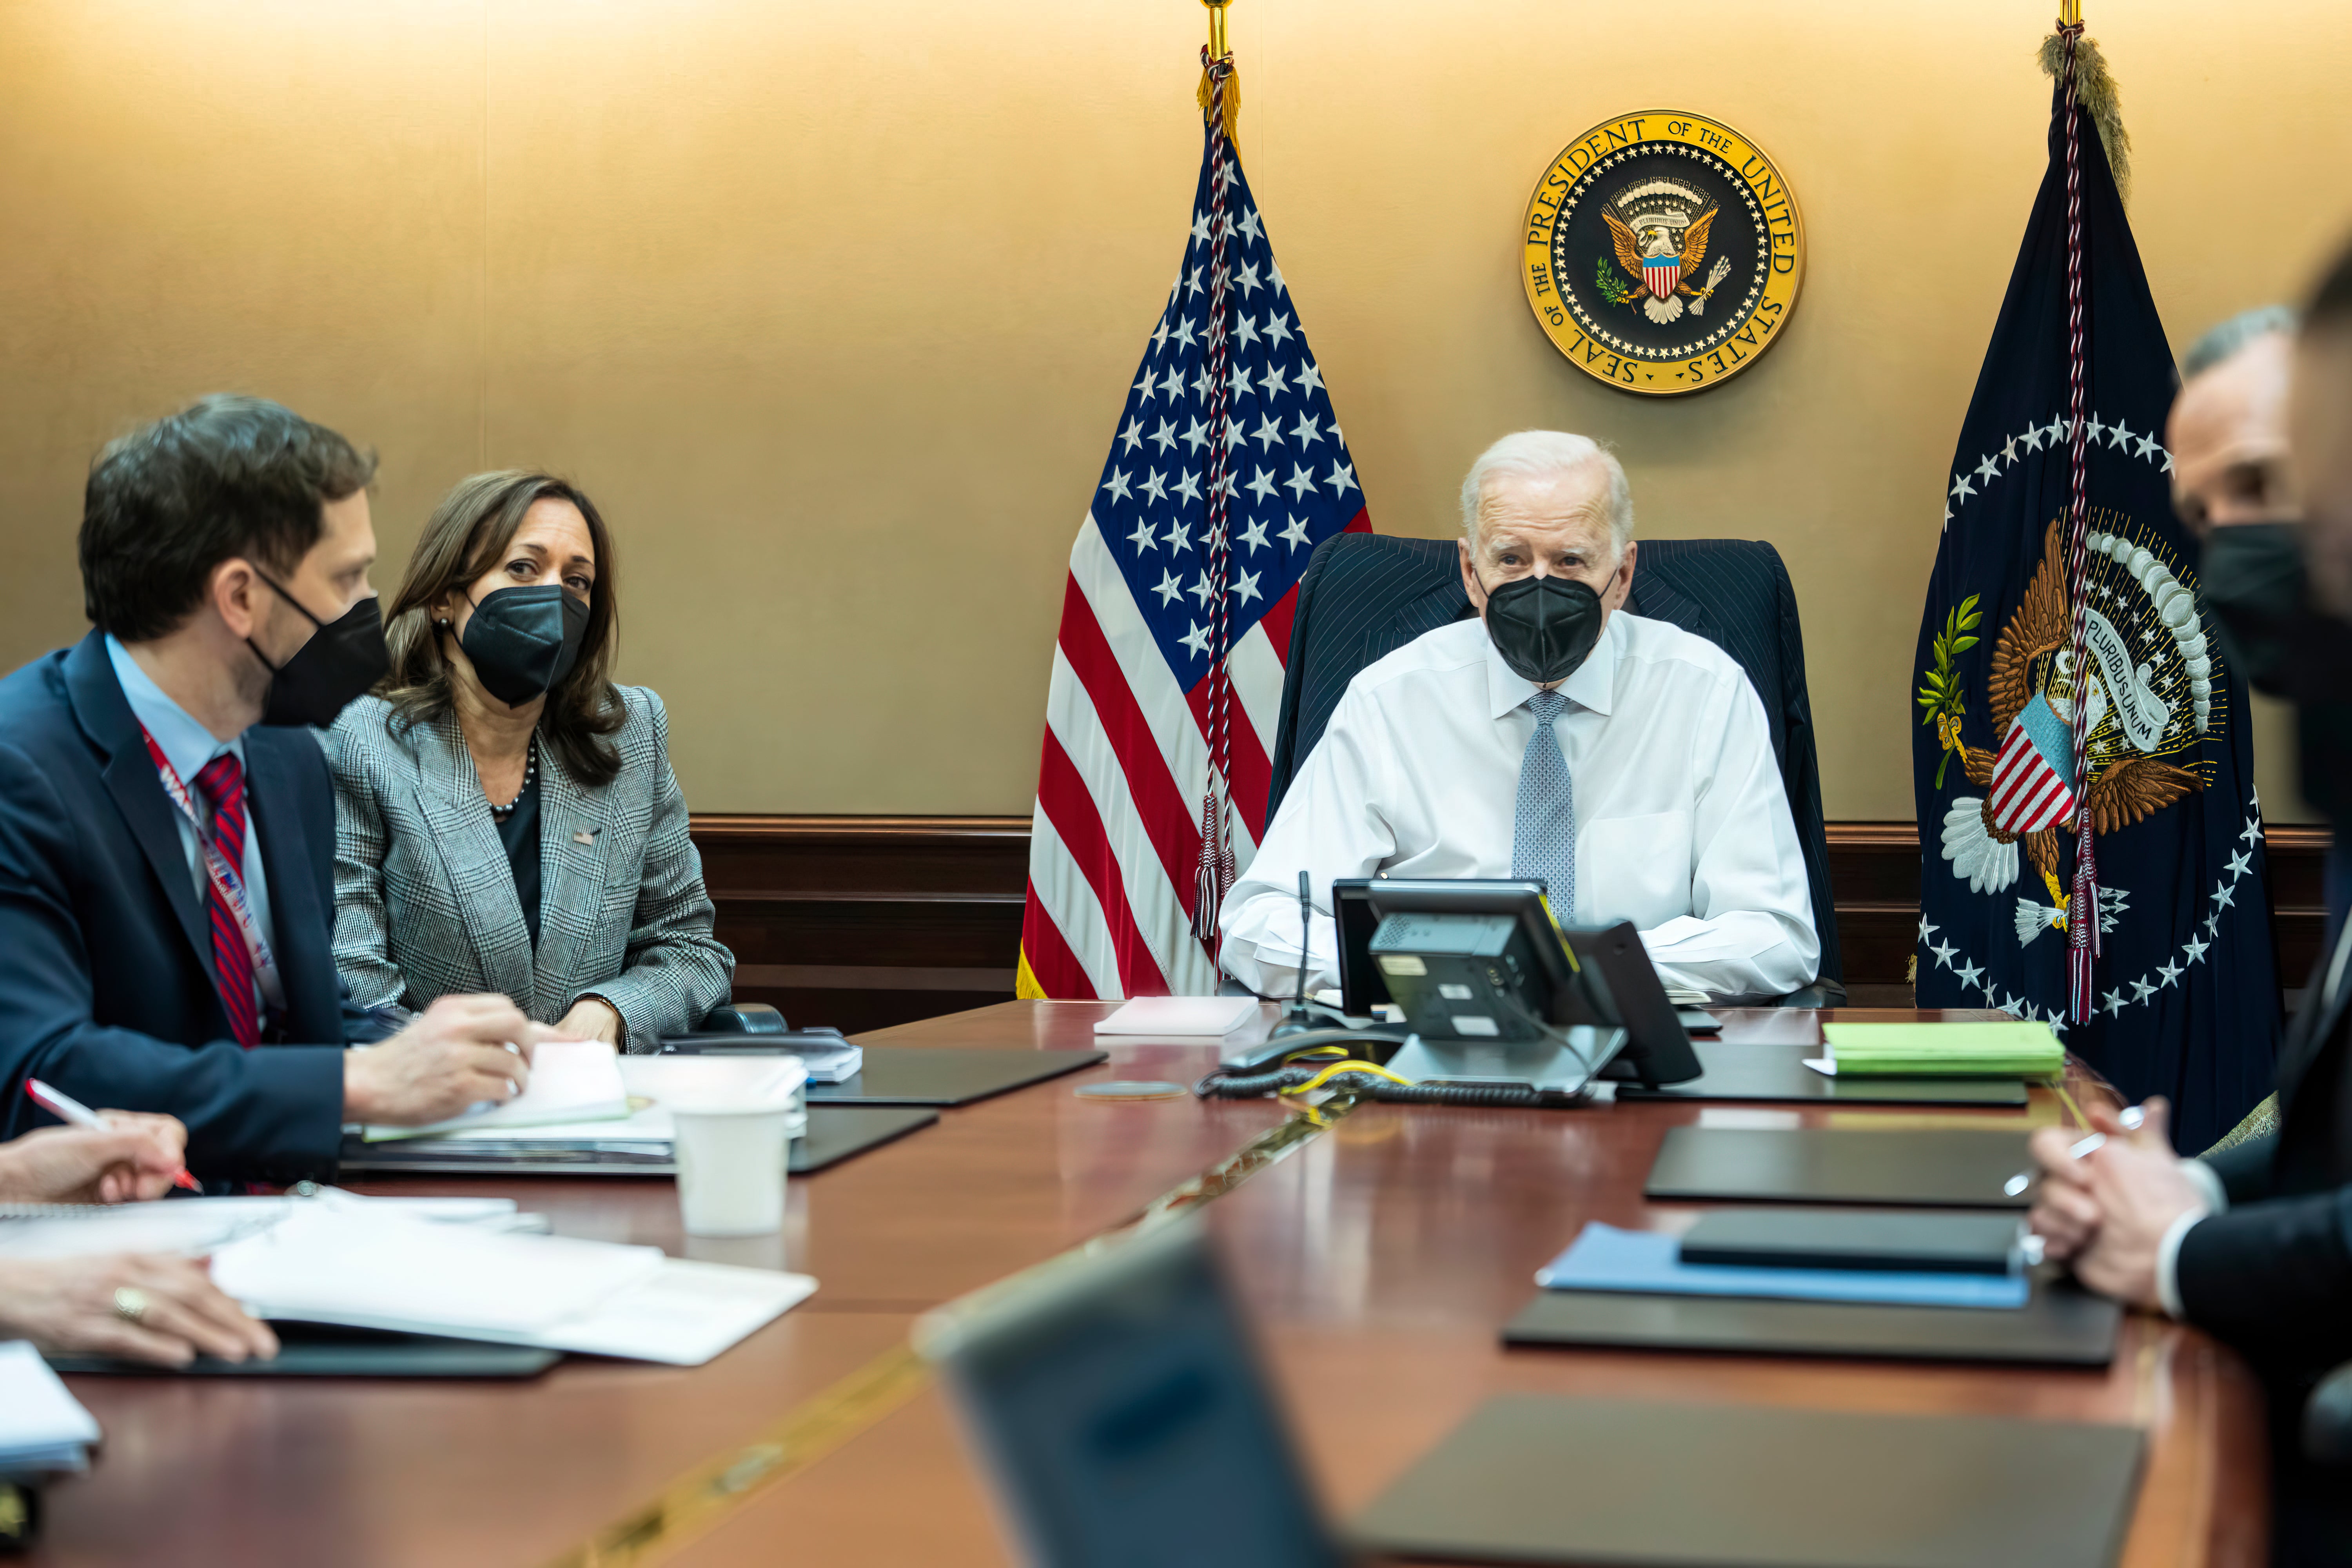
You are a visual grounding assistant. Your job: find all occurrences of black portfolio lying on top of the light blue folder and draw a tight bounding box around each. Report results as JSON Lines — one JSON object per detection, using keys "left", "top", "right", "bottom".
{"left": 1682, "top": 1206, "right": 2025, "bottom": 1274}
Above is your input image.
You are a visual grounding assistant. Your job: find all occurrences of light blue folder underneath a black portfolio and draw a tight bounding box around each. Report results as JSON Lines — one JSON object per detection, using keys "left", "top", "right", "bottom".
{"left": 1536, "top": 1225, "right": 2032, "bottom": 1307}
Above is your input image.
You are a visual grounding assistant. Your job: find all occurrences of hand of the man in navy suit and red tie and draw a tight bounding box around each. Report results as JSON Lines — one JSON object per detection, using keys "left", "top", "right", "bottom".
{"left": 343, "top": 997, "right": 562, "bottom": 1126}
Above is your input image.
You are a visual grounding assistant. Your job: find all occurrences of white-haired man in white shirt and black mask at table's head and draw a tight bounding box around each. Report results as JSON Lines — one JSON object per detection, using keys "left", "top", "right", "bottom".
{"left": 1218, "top": 430, "right": 1820, "bottom": 997}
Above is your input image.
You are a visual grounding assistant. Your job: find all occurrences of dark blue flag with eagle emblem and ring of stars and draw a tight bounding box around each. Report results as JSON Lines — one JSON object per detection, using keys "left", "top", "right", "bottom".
{"left": 1912, "top": 31, "right": 2277, "bottom": 1152}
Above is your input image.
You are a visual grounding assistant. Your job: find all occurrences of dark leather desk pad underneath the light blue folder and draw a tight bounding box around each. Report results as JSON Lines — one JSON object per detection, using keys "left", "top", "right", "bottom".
{"left": 1503, "top": 1274, "right": 2124, "bottom": 1366}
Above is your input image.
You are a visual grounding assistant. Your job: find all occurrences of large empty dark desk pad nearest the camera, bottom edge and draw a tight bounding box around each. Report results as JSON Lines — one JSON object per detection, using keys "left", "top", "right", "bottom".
{"left": 1352, "top": 1394, "right": 2143, "bottom": 1568}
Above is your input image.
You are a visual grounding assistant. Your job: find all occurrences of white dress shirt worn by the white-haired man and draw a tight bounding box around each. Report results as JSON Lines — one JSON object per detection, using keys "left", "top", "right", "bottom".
{"left": 1218, "top": 611, "right": 1820, "bottom": 997}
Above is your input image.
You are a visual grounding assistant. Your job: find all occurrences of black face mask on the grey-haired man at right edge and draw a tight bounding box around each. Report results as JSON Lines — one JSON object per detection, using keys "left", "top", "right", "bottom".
{"left": 2199, "top": 522, "right": 2352, "bottom": 837}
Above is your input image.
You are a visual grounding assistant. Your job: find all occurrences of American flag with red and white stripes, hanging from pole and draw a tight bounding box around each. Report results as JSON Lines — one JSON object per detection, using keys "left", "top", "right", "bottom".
{"left": 1018, "top": 85, "right": 1371, "bottom": 999}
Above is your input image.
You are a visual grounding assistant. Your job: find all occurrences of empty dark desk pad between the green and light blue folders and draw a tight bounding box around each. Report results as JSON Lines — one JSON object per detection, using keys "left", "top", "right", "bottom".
{"left": 1642, "top": 1126, "right": 2032, "bottom": 1208}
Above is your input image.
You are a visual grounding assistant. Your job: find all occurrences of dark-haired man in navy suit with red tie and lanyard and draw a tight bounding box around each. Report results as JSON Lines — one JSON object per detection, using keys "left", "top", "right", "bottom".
{"left": 0, "top": 397, "right": 560, "bottom": 1180}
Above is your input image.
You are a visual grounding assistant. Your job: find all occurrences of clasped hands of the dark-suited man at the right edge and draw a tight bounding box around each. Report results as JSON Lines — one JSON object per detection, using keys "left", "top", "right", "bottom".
{"left": 2032, "top": 1100, "right": 2206, "bottom": 1307}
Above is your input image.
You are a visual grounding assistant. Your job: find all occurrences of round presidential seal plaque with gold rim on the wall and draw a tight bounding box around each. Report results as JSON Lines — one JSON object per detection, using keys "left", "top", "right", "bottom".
{"left": 1519, "top": 108, "right": 1804, "bottom": 397}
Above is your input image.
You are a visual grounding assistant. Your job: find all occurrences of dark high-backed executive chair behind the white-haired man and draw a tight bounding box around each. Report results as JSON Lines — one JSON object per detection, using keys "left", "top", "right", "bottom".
{"left": 1265, "top": 534, "right": 1846, "bottom": 1006}
